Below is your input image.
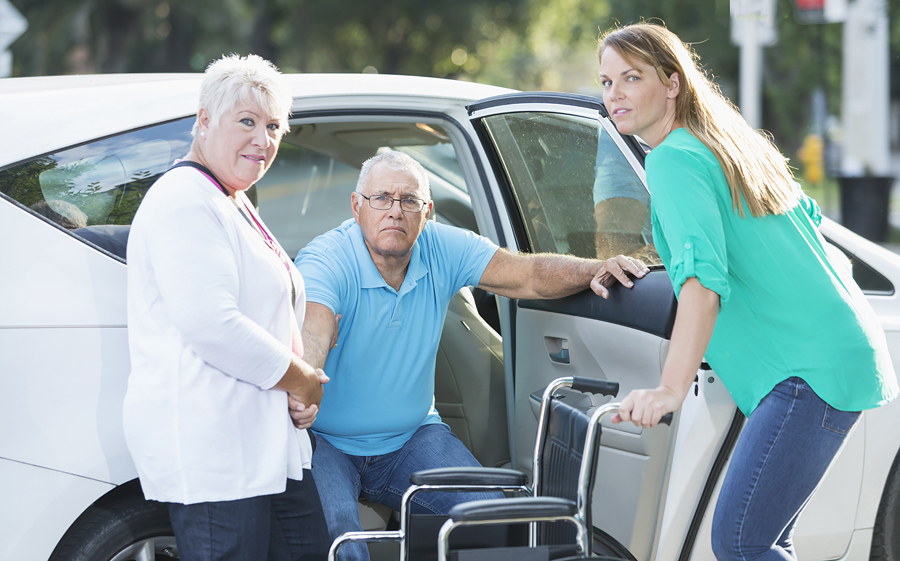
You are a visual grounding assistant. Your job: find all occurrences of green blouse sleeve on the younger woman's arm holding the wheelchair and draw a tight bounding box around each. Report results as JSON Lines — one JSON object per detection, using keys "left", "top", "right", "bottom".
{"left": 646, "top": 144, "right": 731, "bottom": 305}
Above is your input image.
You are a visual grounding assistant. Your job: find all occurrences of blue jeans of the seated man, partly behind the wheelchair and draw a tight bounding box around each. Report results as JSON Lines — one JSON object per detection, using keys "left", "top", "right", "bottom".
{"left": 313, "top": 424, "right": 502, "bottom": 561}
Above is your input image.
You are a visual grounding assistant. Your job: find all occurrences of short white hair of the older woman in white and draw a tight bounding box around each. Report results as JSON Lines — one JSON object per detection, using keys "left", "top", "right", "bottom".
{"left": 191, "top": 54, "right": 293, "bottom": 136}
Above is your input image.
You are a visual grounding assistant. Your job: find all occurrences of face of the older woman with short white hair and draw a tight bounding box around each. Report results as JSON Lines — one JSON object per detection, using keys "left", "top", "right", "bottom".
{"left": 200, "top": 101, "right": 282, "bottom": 194}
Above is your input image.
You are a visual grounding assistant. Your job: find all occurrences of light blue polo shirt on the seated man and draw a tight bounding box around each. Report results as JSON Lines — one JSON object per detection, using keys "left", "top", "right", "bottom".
{"left": 295, "top": 219, "right": 498, "bottom": 456}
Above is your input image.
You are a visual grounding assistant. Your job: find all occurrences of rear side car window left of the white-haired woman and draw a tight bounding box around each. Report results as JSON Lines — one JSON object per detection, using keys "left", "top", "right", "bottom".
{"left": 0, "top": 117, "right": 194, "bottom": 258}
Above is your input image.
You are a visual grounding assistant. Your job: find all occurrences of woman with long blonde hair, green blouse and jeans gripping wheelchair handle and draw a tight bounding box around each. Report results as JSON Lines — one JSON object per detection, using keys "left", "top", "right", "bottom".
{"left": 598, "top": 23, "right": 898, "bottom": 561}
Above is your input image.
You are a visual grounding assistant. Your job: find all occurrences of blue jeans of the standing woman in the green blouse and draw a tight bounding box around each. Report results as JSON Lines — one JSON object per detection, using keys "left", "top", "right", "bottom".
{"left": 712, "top": 377, "right": 860, "bottom": 561}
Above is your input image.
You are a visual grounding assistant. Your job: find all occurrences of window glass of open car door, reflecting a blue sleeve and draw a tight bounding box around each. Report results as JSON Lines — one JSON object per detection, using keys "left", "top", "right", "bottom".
{"left": 483, "top": 112, "right": 661, "bottom": 265}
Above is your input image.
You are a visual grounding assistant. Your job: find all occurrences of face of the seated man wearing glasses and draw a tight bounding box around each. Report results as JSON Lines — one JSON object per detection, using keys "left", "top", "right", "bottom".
{"left": 350, "top": 164, "right": 433, "bottom": 259}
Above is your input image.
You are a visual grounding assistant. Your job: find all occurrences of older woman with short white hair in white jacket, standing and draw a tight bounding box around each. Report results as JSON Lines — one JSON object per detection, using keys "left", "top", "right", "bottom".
{"left": 124, "top": 55, "right": 329, "bottom": 561}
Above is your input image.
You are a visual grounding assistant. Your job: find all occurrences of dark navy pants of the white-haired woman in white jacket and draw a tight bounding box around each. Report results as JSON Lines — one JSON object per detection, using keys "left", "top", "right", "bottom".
{"left": 169, "top": 470, "right": 331, "bottom": 561}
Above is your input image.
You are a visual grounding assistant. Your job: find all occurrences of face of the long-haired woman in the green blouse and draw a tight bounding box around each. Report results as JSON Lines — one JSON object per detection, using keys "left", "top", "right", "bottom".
{"left": 600, "top": 47, "right": 679, "bottom": 147}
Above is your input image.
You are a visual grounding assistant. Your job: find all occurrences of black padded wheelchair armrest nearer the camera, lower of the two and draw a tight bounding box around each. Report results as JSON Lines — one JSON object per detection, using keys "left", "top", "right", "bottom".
{"left": 450, "top": 497, "right": 578, "bottom": 522}
